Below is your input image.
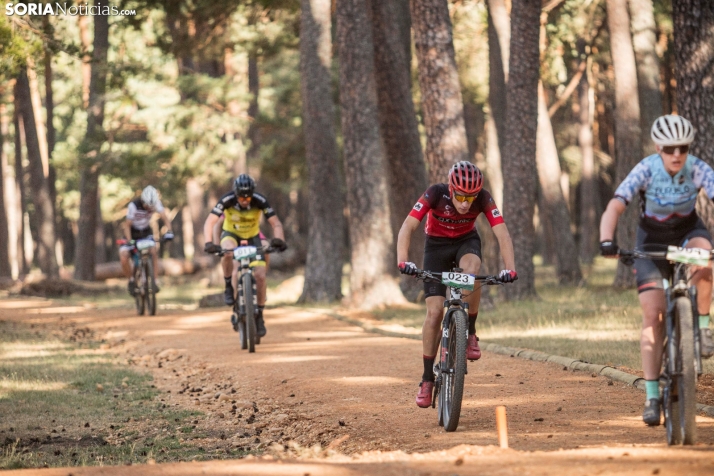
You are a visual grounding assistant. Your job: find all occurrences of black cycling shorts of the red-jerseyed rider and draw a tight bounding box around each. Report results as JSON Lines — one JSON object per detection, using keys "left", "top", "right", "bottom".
{"left": 423, "top": 230, "right": 481, "bottom": 297}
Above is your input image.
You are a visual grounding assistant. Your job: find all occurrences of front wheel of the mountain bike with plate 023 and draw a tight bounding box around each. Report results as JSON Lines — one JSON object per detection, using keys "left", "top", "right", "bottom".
{"left": 439, "top": 310, "right": 468, "bottom": 431}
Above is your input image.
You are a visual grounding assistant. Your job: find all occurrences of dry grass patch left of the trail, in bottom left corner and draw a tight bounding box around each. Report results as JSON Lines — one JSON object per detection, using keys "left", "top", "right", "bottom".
{"left": 0, "top": 321, "right": 253, "bottom": 469}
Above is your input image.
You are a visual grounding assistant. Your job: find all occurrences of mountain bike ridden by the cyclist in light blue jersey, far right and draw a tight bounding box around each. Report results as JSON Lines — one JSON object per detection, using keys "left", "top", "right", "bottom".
{"left": 620, "top": 246, "right": 713, "bottom": 445}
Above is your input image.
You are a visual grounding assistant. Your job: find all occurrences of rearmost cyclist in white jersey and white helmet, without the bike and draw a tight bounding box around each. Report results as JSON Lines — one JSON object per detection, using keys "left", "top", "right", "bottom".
{"left": 119, "top": 185, "right": 174, "bottom": 296}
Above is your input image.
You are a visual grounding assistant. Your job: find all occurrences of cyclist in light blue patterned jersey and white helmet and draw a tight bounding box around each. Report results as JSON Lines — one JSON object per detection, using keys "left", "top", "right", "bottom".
{"left": 600, "top": 115, "right": 714, "bottom": 425}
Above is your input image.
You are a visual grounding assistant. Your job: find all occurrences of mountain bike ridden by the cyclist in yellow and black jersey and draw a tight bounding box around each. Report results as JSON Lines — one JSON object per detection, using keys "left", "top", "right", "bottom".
{"left": 211, "top": 241, "right": 278, "bottom": 353}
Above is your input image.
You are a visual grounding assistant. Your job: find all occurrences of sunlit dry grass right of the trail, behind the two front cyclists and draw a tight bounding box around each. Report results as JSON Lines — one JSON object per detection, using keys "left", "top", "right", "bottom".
{"left": 375, "top": 259, "right": 714, "bottom": 373}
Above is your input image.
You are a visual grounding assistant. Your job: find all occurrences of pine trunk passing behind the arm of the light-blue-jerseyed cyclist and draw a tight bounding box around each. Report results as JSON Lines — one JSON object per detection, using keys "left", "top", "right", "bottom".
{"left": 607, "top": 0, "right": 642, "bottom": 288}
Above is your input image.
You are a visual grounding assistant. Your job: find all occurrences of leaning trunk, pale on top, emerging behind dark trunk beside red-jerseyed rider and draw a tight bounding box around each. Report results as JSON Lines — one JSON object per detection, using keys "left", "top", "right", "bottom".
{"left": 536, "top": 83, "right": 583, "bottom": 284}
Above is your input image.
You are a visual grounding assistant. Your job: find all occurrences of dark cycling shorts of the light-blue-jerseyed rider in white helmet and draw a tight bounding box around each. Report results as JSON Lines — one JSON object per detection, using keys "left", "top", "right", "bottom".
{"left": 633, "top": 219, "right": 712, "bottom": 293}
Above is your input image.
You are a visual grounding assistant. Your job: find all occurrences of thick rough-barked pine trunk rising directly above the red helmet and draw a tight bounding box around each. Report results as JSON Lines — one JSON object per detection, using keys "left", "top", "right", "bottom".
{"left": 411, "top": 0, "right": 469, "bottom": 183}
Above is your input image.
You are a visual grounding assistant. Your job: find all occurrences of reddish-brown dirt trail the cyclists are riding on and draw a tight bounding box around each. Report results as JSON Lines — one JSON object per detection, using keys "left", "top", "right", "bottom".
{"left": 3, "top": 307, "right": 714, "bottom": 475}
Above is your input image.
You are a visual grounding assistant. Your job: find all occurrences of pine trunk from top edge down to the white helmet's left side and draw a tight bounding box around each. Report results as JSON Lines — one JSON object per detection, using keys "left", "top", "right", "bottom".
{"left": 629, "top": 0, "right": 663, "bottom": 155}
